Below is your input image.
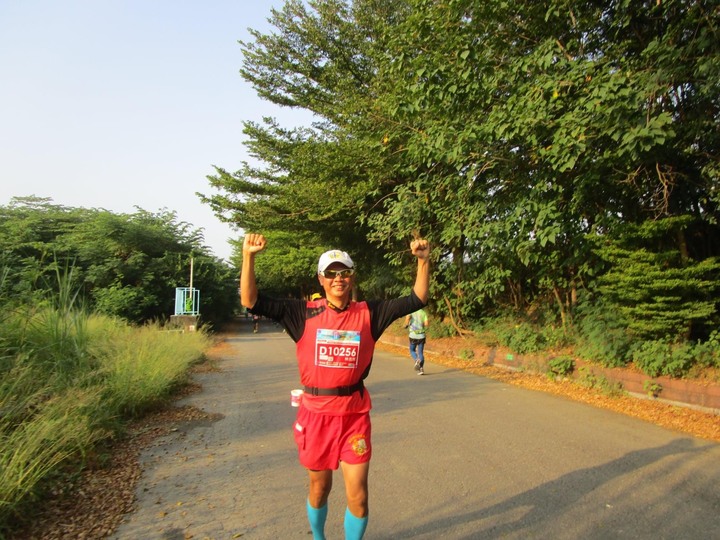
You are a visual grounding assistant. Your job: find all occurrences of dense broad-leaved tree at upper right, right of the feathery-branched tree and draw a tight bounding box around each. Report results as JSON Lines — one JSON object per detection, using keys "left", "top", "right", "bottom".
{"left": 368, "top": 0, "right": 718, "bottom": 315}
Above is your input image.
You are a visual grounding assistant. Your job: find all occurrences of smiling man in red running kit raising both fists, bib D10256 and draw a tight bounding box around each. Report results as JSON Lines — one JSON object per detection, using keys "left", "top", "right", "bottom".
{"left": 240, "top": 234, "right": 430, "bottom": 540}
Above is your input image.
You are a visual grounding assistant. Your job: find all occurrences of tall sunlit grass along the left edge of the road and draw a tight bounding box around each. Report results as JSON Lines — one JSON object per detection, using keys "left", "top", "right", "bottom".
{"left": 0, "top": 274, "right": 210, "bottom": 538}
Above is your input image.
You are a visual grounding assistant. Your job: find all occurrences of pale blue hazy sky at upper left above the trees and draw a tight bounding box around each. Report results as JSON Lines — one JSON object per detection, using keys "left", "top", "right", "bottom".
{"left": 0, "top": 0, "right": 309, "bottom": 259}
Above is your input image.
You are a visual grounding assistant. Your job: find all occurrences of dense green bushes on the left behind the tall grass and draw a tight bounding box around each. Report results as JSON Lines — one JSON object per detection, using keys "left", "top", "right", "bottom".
{"left": 0, "top": 198, "right": 238, "bottom": 323}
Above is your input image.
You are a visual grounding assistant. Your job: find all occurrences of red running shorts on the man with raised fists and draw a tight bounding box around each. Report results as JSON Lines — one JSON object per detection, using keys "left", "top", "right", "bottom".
{"left": 293, "top": 405, "right": 372, "bottom": 471}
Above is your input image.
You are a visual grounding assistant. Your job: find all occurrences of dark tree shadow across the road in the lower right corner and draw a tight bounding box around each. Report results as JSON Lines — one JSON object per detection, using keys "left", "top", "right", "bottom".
{"left": 387, "top": 438, "right": 720, "bottom": 540}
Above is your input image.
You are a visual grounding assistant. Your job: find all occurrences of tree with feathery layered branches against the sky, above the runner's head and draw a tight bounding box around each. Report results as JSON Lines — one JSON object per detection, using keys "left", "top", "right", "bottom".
{"left": 201, "top": 0, "right": 414, "bottom": 296}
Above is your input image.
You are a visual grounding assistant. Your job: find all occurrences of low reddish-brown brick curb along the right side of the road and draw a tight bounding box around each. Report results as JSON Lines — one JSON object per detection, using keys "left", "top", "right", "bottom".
{"left": 380, "top": 335, "right": 720, "bottom": 415}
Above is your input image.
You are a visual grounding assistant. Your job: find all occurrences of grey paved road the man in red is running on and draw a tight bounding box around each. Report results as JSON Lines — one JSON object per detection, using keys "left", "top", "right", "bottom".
{"left": 115, "top": 325, "right": 720, "bottom": 540}
